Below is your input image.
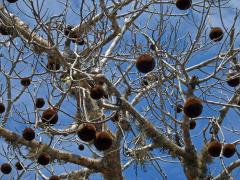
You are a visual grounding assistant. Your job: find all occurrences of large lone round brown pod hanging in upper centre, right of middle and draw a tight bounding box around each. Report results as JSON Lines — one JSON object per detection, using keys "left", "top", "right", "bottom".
{"left": 136, "top": 54, "right": 155, "bottom": 73}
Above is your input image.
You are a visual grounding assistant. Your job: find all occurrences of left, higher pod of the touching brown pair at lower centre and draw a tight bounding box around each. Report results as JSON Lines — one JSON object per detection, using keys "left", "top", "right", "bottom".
{"left": 77, "top": 124, "right": 96, "bottom": 142}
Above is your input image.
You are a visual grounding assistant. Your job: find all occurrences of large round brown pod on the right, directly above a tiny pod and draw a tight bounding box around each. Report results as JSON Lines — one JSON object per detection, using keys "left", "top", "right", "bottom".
{"left": 183, "top": 97, "right": 203, "bottom": 118}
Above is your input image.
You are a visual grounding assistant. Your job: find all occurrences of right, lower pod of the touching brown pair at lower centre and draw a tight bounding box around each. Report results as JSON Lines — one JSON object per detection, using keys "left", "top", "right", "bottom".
{"left": 94, "top": 131, "right": 113, "bottom": 151}
